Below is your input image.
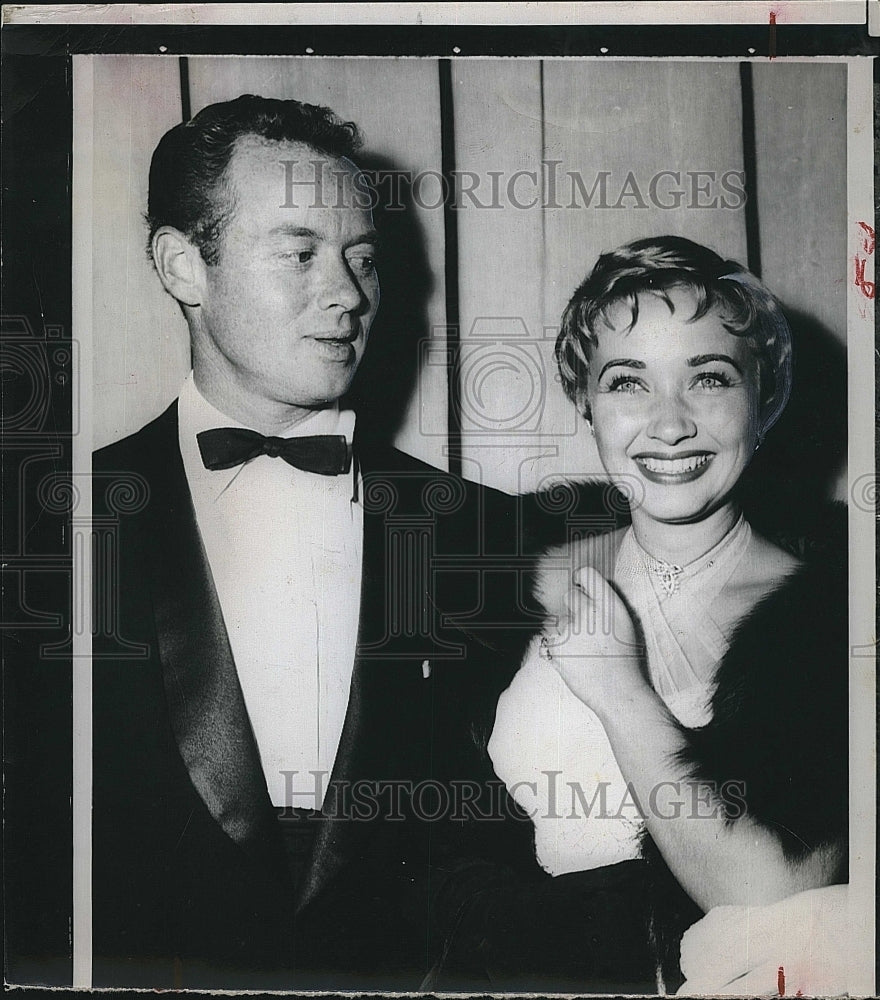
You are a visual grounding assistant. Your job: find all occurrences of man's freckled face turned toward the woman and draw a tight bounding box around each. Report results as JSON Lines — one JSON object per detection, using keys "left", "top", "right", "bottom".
{"left": 193, "top": 136, "right": 379, "bottom": 420}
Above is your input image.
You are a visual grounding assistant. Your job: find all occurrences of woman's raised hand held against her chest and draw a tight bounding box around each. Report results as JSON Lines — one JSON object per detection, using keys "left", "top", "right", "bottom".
{"left": 542, "top": 566, "right": 647, "bottom": 717}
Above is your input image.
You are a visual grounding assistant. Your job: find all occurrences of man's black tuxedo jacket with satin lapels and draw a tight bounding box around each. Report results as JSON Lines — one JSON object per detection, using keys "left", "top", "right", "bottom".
{"left": 93, "top": 403, "right": 537, "bottom": 990}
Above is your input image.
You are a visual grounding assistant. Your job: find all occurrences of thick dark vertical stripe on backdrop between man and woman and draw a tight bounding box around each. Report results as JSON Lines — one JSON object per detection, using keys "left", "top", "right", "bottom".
{"left": 438, "top": 59, "right": 461, "bottom": 476}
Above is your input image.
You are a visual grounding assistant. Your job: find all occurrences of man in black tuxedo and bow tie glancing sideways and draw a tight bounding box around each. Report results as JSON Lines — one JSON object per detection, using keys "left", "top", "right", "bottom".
{"left": 93, "top": 96, "right": 527, "bottom": 989}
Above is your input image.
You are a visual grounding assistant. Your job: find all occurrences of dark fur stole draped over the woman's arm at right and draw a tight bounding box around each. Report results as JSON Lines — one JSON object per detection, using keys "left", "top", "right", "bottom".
{"left": 642, "top": 505, "right": 849, "bottom": 989}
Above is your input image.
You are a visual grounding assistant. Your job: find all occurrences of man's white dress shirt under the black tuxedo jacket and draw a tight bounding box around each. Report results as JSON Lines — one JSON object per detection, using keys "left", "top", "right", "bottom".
{"left": 178, "top": 373, "right": 363, "bottom": 809}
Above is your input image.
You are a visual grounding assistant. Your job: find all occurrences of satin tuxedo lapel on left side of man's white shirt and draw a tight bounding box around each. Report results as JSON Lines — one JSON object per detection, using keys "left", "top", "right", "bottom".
{"left": 138, "top": 403, "right": 281, "bottom": 866}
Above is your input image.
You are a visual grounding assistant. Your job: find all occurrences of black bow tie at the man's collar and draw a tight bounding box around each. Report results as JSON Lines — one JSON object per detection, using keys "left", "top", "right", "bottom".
{"left": 196, "top": 427, "right": 351, "bottom": 476}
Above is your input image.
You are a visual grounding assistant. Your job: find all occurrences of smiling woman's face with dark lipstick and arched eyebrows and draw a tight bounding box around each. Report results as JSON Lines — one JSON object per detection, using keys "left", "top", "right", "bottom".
{"left": 588, "top": 289, "right": 759, "bottom": 523}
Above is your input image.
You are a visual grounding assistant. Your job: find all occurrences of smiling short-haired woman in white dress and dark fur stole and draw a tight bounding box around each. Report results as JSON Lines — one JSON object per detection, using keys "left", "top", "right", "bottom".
{"left": 430, "top": 237, "right": 847, "bottom": 989}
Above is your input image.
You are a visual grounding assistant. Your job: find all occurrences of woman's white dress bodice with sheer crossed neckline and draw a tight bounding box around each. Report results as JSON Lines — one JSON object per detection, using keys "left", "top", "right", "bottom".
{"left": 489, "top": 518, "right": 752, "bottom": 875}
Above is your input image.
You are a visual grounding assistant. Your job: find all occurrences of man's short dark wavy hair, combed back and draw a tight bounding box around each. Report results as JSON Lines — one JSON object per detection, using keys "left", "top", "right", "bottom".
{"left": 146, "top": 94, "right": 361, "bottom": 264}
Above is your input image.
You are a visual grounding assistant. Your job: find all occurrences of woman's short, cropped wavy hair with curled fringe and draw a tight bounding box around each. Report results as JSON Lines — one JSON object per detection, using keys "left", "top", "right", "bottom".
{"left": 555, "top": 236, "right": 792, "bottom": 437}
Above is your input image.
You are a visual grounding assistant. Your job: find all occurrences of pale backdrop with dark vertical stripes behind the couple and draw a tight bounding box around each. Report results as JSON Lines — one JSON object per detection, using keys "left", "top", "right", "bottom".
{"left": 89, "top": 56, "right": 848, "bottom": 495}
